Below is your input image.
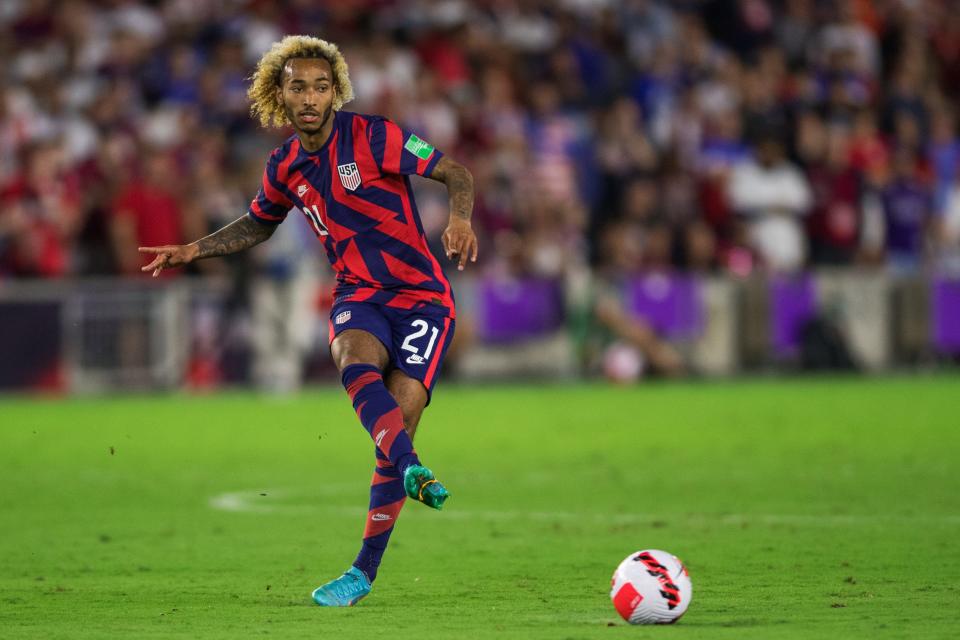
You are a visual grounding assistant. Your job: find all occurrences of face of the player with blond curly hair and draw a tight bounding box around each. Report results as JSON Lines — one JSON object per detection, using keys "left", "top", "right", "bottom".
{"left": 277, "top": 58, "right": 336, "bottom": 135}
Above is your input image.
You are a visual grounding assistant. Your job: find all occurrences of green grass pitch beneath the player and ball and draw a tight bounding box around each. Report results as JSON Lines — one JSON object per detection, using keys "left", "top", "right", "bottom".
{"left": 0, "top": 376, "right": 960, "bottom": 640}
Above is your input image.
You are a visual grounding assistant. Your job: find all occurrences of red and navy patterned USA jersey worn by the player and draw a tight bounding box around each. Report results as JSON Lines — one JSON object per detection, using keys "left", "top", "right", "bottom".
{"left": 248, "top": 111, "right": 454, "bottom": 317}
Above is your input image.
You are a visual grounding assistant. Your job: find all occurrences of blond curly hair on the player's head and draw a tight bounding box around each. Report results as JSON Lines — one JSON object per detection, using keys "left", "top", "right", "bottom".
{"left": 247, "top": 36, "right": 353, "bottom": 127}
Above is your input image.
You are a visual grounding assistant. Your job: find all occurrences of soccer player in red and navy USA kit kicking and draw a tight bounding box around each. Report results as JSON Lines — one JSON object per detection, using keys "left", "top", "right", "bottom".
{"left": 140, "top": 36, "right": 477, "bottom": 606}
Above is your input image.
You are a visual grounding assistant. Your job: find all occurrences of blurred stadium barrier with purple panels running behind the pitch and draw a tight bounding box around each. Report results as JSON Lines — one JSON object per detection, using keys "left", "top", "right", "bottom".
{"left": 0, "top": 270, "right": 960, "bottom": 393}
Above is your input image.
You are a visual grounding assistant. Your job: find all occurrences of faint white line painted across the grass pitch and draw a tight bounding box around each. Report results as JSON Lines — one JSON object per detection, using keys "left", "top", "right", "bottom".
{"left": 208, "top": 485, "right": 960, "bottom": 527}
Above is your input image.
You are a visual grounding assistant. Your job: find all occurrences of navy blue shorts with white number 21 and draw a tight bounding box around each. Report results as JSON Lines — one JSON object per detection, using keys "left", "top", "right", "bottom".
{"left": 330, "top": 300, "right": 455, "bottom": 403}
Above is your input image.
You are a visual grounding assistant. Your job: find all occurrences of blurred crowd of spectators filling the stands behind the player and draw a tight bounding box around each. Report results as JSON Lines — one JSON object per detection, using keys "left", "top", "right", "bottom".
{"left": 0, "top": 0, "right": 960, "bottom": 278}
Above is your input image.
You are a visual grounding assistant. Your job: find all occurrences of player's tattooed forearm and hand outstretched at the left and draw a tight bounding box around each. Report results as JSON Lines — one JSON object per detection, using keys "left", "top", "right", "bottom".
{"left": 138, "top": 215, "right": 276, "bottom": 278}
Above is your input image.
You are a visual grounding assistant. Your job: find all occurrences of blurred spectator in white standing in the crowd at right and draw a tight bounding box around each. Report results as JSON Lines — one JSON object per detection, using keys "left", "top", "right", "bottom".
{"left": 730, "top": 132, "right": 812, "bottom": 271}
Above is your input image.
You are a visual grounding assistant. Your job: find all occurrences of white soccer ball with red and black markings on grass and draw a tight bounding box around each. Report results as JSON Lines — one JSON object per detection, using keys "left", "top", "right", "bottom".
{"left": 610, "top": 549, "right": 693, "bottom": 624}
